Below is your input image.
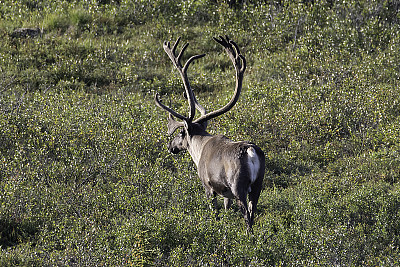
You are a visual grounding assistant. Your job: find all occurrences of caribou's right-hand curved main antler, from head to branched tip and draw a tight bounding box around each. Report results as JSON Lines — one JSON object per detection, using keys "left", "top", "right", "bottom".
{"left": 195, "top": 36, "right": 246, "bottom": 123}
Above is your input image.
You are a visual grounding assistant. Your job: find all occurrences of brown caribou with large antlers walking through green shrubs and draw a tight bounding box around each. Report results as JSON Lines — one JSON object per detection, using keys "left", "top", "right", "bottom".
{"left": 154, "top": 36, "right": 265, "bottom": 230}
